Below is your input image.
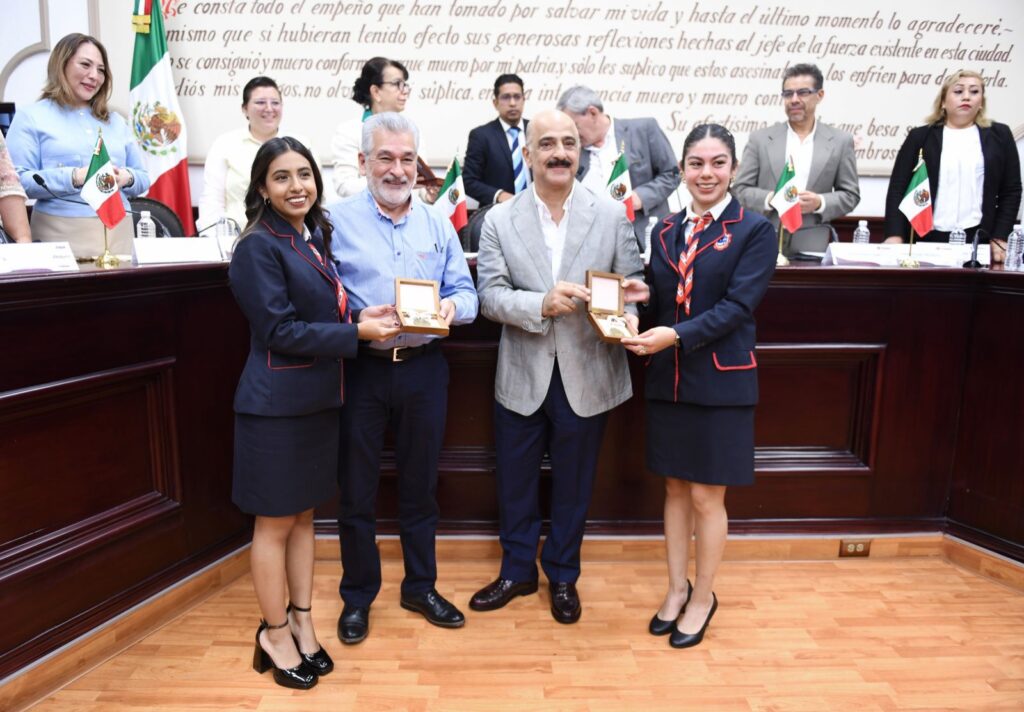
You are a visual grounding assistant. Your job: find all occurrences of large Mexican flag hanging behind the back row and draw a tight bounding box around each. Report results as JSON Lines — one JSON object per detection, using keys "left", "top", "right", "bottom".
{"left": 131, "top": 0, "right": 196, "bottom": 235}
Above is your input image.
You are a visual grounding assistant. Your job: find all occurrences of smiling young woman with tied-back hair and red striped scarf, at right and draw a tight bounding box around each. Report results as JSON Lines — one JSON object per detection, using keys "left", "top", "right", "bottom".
{"left": 623, "top": 124, "right": 776, "bottom": 647}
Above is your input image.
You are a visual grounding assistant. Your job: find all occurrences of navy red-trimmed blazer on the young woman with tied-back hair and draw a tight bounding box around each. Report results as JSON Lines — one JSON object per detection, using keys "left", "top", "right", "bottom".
{"left": 645, "top": 198, "right": 778, "bottom": 406}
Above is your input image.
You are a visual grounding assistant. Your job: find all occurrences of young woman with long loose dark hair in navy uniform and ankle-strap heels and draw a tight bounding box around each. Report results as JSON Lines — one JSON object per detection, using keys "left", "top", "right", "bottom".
{"left": 228, "top": 137, "right": 397, "bottom": 689}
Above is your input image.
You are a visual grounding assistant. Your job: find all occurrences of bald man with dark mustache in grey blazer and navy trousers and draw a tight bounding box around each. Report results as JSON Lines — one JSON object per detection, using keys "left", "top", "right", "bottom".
{"left": 469, "top": 110, "right": 643, "bottom": 623}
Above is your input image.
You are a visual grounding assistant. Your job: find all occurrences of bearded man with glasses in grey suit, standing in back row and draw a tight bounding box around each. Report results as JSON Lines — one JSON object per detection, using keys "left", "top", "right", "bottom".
{"left": 733, "top": 65, "right": 860, "bottom": 255}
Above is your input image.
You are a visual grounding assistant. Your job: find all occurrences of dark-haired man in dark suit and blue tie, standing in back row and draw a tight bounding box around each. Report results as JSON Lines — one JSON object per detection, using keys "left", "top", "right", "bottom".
{"left": 462, "top": 74, "right": 529, "bottom": 208}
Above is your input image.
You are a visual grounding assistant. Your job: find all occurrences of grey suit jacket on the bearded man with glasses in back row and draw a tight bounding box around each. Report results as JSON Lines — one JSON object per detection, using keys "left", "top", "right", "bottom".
{"left": 732, "top": 121, "right": 860, "bottom": 227}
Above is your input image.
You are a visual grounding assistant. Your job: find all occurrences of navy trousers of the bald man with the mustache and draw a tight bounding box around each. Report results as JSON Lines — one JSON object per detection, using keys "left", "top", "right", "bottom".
{"left": 495, "top": 363, "right": 608, "bottom": 583}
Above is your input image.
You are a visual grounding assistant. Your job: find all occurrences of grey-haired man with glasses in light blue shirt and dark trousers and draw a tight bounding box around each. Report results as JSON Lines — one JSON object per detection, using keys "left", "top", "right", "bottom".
{"left": 330, "top": 112, "right": 477, "bottom": 644}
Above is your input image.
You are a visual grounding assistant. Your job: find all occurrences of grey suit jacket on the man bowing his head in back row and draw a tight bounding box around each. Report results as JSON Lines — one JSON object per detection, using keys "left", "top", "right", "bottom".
{"left": 577, "top": 118, "right": 679, "bottom": 247}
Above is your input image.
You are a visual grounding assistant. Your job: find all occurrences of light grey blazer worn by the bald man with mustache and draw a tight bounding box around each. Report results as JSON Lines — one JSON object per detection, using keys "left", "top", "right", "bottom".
{"left": 476, "top": 183, "right": 643, "bottom": 417}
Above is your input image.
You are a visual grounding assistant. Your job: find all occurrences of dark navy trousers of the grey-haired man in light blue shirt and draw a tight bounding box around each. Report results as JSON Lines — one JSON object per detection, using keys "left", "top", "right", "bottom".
{"left": 338, "top": 348, "right": 449, "bottom": 606}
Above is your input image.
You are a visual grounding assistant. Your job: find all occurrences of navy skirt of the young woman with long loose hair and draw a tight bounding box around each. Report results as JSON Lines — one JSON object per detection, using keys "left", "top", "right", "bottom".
{"left": 231, "top": 409, "right": 341, "bottom": 516}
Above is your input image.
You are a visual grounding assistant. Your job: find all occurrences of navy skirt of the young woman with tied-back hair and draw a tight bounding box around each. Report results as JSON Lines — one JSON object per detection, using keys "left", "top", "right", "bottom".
{"left": 646, "top": 401, "right": 754, "bottom": 487}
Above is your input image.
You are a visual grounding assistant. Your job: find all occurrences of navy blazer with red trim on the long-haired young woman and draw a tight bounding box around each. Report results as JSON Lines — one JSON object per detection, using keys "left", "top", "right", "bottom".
{"left": 227, "top": 210, "right": 358, "bottom": 416}
